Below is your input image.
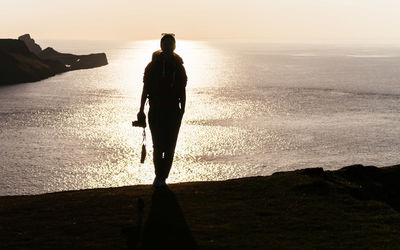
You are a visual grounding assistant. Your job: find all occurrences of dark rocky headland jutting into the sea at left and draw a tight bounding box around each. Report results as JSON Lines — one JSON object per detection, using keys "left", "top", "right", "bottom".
{"left": 0, "top": 34, "right": 108, "bottom": 85}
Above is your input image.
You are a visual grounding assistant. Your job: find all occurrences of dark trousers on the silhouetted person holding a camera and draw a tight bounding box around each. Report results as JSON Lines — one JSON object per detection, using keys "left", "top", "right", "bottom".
{"left": 148, "top": 106, "right": 182, "bottom": 179}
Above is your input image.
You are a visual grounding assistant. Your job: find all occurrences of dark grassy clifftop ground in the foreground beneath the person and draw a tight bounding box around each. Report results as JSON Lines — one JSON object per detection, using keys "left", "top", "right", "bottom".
{"left": 0, "top": 165, "right": 400, "bottom": 249}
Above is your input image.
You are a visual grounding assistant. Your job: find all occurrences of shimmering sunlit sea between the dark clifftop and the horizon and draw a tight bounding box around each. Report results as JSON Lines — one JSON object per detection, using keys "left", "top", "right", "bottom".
{"left": 0, "top": 41, "right": 400, "bottom": 195}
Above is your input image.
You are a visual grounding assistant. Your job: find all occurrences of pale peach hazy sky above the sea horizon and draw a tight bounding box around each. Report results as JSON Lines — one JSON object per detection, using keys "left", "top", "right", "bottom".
{"left": 0, "top": 0, "right": 400, "bottom": 42}
